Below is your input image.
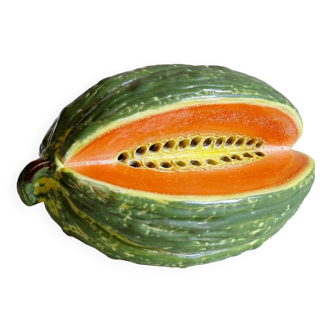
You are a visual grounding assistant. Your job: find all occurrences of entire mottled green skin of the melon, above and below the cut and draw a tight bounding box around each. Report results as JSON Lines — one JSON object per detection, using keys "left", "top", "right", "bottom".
{"left": 18, "top": 65, "right": 315, "bottom": 268}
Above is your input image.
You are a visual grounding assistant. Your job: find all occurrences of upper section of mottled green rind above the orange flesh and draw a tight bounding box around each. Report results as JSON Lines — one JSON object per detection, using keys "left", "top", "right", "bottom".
{"left": 40, "top": 64, "right": 302, "bottom": 158}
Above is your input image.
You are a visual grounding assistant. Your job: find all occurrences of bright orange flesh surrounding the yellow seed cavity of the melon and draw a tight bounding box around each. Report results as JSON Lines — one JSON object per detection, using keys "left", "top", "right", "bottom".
{"left": 65, "top": 104, "right": 309, "bottom": 195}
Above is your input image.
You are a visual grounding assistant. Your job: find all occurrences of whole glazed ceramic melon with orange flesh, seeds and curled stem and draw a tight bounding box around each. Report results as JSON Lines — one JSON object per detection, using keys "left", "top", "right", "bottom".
{"left": 17, "top": 64, "right": 315, "bottom": 268}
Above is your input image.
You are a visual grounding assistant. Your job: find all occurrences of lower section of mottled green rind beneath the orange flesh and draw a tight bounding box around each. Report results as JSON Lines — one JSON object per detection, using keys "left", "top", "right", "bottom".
{"left": 38, "top": 162, "right": 315, "bottom": 268}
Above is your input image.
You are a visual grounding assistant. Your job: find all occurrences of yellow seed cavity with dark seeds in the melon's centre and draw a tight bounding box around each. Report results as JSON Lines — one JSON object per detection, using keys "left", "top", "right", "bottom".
{"left": 116, "top": 134, "right": 266, "bottom": 172}
